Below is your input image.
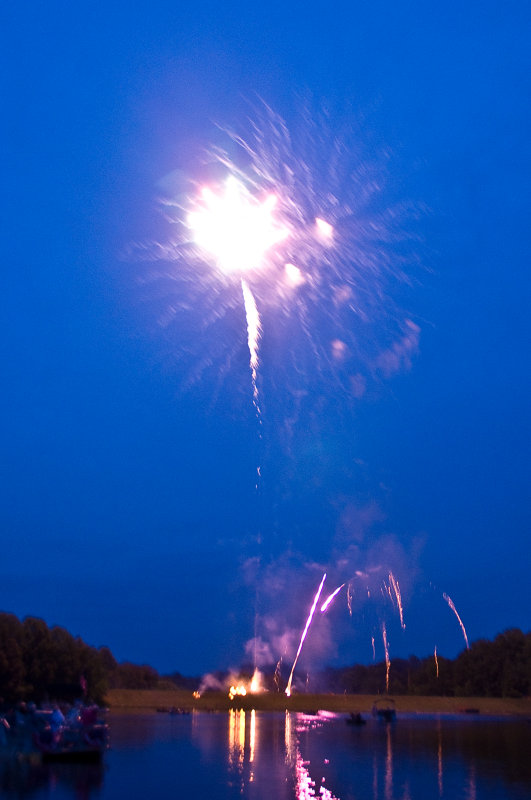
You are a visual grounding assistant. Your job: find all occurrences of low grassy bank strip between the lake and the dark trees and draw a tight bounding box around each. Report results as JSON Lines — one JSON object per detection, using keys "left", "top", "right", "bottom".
{"left": 106, "top": 689, "right": 531, "bottom": 719}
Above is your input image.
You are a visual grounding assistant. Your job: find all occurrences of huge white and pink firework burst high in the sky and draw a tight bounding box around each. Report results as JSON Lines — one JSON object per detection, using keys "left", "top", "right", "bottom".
{"left": 138, "top": 97, "right": 419, "bottom": 416}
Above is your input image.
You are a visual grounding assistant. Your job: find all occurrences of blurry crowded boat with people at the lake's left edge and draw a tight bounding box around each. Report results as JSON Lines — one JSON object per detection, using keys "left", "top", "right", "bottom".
{"left": 0, "top": 704, "right": 109, "bottom": 762}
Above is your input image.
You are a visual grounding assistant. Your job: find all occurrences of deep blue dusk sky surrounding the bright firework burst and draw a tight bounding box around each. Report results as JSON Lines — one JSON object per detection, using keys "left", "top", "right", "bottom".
{"left": 0, "top": 0, "right": 531, "bottom": 674}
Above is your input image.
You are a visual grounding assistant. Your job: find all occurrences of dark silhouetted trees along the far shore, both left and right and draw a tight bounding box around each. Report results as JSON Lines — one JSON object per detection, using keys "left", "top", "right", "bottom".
{"left": 0, "top": 612, "right": 531, "bottom": 703}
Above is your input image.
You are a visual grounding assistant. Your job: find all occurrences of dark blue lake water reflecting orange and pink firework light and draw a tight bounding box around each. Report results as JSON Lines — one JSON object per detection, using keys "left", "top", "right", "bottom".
{"left": 0, "top": 711, "right": 531, "bottom": 800}
